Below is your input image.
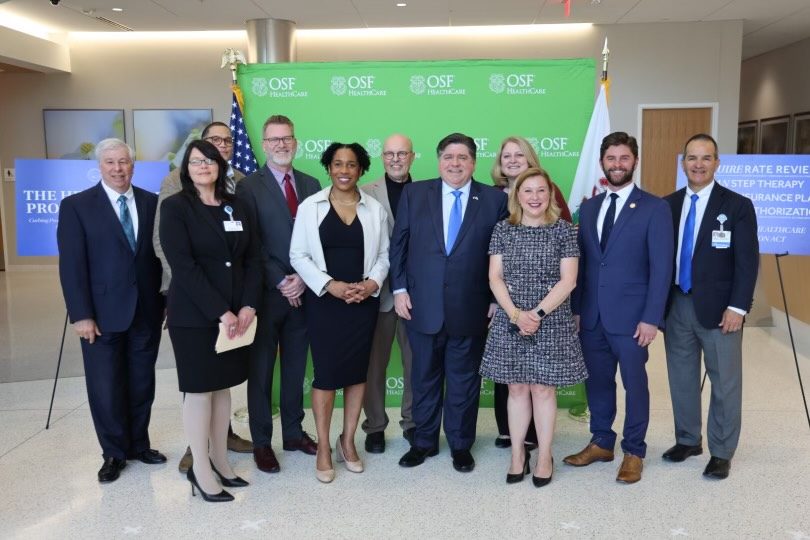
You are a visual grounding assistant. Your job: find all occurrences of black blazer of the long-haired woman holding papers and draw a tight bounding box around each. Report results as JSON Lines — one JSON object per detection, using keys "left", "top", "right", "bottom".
{"left": 160, "top": 193, "right": 262, "bottom": 328}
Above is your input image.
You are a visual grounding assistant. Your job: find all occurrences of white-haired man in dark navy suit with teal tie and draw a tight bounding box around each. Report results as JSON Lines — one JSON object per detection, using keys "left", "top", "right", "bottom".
{"left": 56, "top": 139, "right": 166, "bottom": 483}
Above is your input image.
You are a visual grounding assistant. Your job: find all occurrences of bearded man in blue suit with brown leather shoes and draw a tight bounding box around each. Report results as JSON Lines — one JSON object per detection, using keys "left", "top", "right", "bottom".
{"left": 564, "top": 132, "right": 673, "bottom": 484}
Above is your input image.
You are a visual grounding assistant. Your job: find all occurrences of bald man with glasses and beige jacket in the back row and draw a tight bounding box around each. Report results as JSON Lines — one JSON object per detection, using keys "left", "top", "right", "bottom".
{"left": 360, "top": 134, "right": 414, "bottom": 454}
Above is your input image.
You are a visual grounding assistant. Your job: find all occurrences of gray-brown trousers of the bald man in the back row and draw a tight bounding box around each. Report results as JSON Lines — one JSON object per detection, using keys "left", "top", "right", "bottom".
{"left": 362, "top": 309, "right": 415, "bottom": 433}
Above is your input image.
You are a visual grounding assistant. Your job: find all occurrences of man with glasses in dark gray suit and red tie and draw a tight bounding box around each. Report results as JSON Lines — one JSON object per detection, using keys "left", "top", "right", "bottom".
{"left": 236, "top": 115, "right": 321, "bottom": 473}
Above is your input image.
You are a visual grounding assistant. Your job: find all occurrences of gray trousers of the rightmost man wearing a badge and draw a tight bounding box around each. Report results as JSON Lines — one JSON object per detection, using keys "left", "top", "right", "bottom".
{"left": 664, "top": 291, "right": 742, "bottom": 459}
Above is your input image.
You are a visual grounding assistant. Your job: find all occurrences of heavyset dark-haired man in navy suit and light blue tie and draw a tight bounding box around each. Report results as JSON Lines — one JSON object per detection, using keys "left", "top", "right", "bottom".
{"left": 390, "top": 133, "right": 508, "bottom": 472}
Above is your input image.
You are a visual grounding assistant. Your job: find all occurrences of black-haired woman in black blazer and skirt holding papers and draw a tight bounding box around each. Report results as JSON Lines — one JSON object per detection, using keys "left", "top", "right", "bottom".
{"left": 160, "top": 141, "right": 262, "bottom": 502}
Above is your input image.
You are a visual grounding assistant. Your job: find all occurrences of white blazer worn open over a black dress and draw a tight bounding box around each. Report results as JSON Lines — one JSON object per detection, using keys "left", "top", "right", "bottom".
{"left": 290, "top": 186, "right": 388, "bottom": 296}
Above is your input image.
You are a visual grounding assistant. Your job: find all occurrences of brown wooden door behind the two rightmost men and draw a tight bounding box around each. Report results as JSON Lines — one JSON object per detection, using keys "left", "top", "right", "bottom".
{"left": 639, "top": 107, "right": 712, "bottom": 197}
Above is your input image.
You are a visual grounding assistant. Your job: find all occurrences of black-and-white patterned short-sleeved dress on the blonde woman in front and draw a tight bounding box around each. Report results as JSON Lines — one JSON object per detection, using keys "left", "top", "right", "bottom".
{"left": 481, "top": 219, "right": 588, "bottom": 386}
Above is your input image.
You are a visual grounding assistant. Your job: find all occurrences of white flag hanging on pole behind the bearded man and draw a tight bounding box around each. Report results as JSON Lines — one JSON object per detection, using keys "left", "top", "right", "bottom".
{"left": 568, "top": 81, "right": 610, "bottom": 224}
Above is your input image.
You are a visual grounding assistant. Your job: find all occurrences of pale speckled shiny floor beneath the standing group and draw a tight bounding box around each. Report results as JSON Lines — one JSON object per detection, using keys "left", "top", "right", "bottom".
{"left": 0, "top": 272, "right": 810, "bottom": 539}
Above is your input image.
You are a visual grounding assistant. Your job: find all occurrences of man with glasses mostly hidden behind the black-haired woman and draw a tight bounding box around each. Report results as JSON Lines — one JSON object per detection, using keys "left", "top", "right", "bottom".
{"left": 152, "top": 122, "right": 253, "bottom": 474}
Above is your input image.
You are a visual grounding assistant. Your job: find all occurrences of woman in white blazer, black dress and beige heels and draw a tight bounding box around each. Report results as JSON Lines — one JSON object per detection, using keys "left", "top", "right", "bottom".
{"left": 290, "top": 142, "right": 388, "bottom": 483}
